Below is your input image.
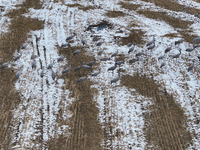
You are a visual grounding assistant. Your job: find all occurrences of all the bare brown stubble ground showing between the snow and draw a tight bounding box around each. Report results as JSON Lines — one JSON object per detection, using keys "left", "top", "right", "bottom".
{"left": 0, "top": 0, "right": 199, "bottom": 150}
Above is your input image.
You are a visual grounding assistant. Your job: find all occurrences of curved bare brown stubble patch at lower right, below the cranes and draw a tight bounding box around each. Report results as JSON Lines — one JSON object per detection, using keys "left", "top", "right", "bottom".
{"left": 121, "top": 75, "right": 192, "bottom": 149}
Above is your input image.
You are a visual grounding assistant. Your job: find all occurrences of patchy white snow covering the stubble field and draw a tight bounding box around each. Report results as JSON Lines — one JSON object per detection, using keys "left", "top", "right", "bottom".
{"left": 0, "top": 0, "right": 200, "bottom": 149}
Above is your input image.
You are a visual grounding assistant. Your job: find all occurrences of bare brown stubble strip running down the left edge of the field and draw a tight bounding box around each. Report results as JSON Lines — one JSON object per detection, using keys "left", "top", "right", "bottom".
{"left": 0, "top": 0, "right": 43, "bottom": 149}
